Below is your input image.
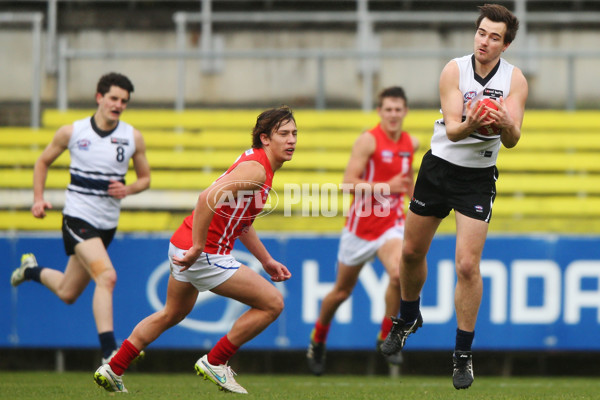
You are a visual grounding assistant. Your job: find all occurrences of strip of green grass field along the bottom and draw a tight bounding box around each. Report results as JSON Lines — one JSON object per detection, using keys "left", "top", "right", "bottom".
{"left": 0, "top": 371, "right": 600, "bottom": 400}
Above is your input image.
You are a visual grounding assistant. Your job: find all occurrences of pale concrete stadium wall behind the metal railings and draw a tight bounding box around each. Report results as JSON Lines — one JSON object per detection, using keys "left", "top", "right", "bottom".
{"left": 0, "top": 28, "right": 600, "bottom": 108}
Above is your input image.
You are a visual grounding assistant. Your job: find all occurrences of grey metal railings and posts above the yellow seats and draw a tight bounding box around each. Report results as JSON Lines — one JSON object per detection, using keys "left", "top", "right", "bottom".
{"left": 0, "top": 0, "right": 600, "bottom": 127}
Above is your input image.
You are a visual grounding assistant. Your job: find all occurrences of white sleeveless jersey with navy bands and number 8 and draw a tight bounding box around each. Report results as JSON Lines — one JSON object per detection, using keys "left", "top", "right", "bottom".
{"left": 63, "top": 118, "right": 135, "bottom": 229}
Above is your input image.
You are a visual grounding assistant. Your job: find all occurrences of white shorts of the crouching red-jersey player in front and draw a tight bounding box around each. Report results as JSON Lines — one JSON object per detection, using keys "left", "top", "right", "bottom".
{"left": 169, "top": 243, "right": 242, "bottom": 292}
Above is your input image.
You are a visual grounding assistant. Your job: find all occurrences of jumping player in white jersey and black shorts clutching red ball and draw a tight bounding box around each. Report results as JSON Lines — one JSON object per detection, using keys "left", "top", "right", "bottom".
{"left": 381, "top": 4, "right": 528, "bottom": 389}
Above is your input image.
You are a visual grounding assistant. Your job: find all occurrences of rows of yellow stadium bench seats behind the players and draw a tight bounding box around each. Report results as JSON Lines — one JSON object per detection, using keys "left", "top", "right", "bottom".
{"left": 0, "top": 108, "right": 600, "bottom": 234}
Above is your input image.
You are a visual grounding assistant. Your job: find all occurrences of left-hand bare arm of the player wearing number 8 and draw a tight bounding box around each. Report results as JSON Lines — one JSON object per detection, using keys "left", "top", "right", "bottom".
{"left": 31, "top": 125, "right": 73, "bottom": 218}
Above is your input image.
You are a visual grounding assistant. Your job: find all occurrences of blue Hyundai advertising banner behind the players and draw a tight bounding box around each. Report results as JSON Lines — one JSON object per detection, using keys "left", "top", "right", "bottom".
{"left": 0, "top": 234, "right": 600, "bottom": 350}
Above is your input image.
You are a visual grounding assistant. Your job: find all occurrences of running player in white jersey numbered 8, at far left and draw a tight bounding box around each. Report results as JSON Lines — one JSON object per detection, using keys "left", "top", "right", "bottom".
{"left": 11, "top": 73, "right": 150, "bottom": 359}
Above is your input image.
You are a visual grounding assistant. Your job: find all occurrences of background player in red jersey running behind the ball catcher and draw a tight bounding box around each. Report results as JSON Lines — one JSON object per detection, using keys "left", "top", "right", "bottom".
{"left": 307, "top": 87, "right": 419, "bottom": 375}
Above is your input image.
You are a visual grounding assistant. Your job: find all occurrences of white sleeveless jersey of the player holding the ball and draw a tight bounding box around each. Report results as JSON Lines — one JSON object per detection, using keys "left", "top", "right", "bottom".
{"left": 431, "top": 54, "right": 514, "bottom": 168}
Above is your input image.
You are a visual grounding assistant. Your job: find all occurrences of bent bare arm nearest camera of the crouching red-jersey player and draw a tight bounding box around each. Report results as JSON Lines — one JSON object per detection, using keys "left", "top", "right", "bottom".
{"left": 173, "top": 161, "right": 267, "bottom": 271}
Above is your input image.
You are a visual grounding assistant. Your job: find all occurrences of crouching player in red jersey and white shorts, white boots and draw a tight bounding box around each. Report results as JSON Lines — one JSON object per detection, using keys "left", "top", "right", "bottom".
{"left": 94, "top": 106, "right": 297, "bottom": 393}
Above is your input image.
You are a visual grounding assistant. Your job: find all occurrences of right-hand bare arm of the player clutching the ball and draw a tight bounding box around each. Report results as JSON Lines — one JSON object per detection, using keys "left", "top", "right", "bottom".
{"left": 495, "top": 67, "right": 529, "bottom": 148}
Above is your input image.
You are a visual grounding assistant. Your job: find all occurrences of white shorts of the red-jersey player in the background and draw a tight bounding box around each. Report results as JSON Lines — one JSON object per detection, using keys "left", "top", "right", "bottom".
{"left": 338, "top": 226, "right": 404, "bottom": 267}
